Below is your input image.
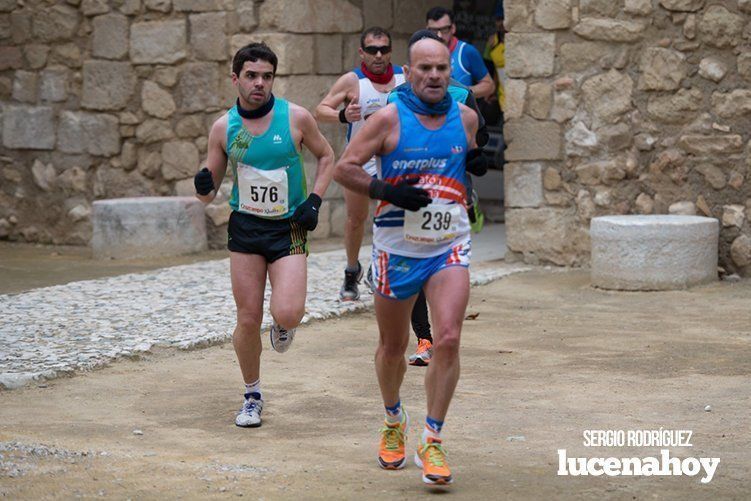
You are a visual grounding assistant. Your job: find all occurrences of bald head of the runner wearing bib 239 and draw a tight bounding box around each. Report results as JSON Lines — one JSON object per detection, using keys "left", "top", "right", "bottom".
{"left": 404, "top": 38, "right": 451, "bottom": 103}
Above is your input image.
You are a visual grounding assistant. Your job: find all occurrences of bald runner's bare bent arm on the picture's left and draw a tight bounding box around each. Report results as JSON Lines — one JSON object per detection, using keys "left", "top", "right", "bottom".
{"left": 334, "top": 104, "right": 399, "bottom": 195}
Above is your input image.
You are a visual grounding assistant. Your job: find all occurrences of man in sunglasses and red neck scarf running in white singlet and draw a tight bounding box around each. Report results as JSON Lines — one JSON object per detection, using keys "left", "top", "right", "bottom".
{"left": 316, "top": 26, "right": 404, "bottom": 301}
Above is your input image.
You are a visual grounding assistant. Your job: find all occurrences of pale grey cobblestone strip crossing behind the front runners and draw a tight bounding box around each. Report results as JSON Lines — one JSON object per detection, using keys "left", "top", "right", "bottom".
{"left": 0, "top": 250, "right": 528, "bottom": 388}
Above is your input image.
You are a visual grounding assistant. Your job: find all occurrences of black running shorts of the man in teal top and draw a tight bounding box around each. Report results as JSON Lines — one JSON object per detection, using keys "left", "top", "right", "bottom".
{"left": 227, "top": 211, "right": 308, "bottom": 263}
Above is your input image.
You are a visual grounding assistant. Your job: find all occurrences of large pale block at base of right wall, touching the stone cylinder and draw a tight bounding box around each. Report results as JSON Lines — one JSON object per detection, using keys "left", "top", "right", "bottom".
{"left": 504, "top": 208, "right": 589, "bottom": 266}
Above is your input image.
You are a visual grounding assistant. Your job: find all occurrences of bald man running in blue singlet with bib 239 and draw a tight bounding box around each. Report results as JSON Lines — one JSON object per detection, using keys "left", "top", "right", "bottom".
{"left": 335, "top": 34, "right": 477, "bottom": 485}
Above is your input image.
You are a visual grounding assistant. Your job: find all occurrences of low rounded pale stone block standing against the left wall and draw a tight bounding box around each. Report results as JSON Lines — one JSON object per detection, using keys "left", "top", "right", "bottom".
{"left": 91, "top": 197, "right": 207, "bottom": 259}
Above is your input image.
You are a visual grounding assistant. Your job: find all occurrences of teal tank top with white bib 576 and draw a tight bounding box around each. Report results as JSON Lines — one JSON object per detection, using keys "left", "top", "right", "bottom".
{"left": 227, "top": 98, "right": 308, "bottom": 219}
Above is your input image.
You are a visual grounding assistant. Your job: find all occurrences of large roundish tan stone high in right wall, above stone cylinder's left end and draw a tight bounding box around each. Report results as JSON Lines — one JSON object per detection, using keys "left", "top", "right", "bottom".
{"left": 582, "top": 70, "right": 634, "bottom": 123}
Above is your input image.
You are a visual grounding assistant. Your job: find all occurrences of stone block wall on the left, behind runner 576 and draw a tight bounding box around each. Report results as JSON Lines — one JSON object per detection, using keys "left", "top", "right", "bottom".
{"left": 0, "top": 0, "right": 451, "bottom": 246}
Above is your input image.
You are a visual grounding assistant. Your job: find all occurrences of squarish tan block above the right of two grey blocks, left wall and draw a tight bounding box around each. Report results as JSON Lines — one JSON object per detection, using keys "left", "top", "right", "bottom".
{"left": 81, "top": 61, "right": 136, "bottom": 110}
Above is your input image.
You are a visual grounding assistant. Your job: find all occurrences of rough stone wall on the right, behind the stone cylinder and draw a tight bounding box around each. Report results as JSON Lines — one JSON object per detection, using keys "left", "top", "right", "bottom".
{"left": 505, "top": 0, "right": 751, "bottom": 275}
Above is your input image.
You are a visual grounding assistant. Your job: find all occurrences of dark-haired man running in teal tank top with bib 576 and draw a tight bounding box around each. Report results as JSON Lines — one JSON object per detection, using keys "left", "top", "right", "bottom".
{"left": 195, "top": 43, "right": 334, "bottom": 427}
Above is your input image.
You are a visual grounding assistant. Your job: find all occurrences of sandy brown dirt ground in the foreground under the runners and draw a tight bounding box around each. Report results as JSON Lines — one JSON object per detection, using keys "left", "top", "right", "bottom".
{"left": 0, "top": 270, "right": 751, "bottom": 499}
